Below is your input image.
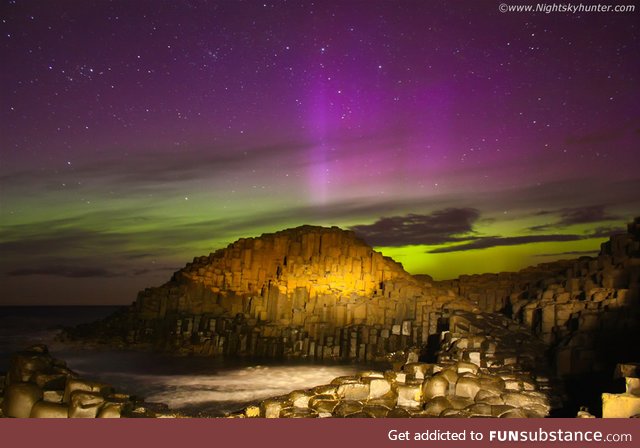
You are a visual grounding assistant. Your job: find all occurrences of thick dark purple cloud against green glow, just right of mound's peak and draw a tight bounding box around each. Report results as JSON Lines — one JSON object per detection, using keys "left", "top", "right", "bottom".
{"left": 351, "top": 208, "right": 480, "bottom": 246}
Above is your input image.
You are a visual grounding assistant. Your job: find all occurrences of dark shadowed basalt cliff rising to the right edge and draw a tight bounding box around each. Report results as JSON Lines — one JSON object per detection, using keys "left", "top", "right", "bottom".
{"left": 434, "top": 218, "right": 640, "bottom": 375}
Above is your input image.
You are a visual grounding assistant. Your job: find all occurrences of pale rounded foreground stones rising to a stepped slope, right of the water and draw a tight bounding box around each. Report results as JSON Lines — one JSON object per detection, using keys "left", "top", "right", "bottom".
{"left": 238, "top": 311, "right": 559, "bottom": 418}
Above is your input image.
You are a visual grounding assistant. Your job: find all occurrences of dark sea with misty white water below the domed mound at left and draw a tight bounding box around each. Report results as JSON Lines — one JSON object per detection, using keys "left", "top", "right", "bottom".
{"left": 0, "top": 306, "right": 371, "bottom": 417}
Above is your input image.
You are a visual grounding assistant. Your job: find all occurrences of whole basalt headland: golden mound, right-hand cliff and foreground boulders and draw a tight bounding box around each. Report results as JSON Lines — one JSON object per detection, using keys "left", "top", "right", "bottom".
{"left": 4, "top": 218, "right": 640, "bottom": 417}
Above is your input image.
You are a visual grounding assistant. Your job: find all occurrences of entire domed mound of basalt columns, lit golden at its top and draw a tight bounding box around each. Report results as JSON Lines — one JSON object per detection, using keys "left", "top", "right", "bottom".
{"left": 71, "top": 226, "right": 473, "bottom": 361}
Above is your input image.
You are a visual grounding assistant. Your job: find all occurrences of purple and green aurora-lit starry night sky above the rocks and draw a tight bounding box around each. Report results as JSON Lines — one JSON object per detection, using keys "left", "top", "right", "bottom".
{"left": 0, "top": 0, "right": 640, "bottom": 304}
